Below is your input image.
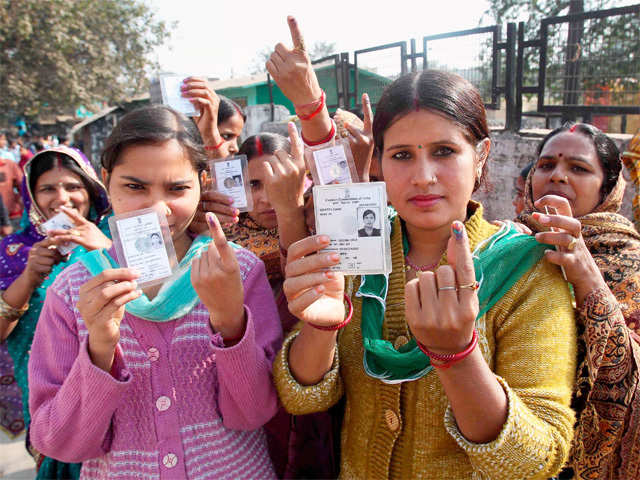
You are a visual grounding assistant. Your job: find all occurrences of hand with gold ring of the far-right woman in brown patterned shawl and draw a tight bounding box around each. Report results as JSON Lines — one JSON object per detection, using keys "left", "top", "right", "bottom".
{"left": 533, "top": 195, "right": 607, "bottom": 306}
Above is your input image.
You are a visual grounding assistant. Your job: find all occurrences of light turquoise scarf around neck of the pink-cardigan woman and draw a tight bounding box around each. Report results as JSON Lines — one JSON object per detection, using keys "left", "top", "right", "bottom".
{"left": 80, "top": 235, "right": 224, "bottom": 323}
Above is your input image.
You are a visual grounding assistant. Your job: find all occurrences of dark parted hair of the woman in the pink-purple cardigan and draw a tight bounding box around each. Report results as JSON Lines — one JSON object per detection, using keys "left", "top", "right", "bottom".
{"left": 100, "top": 105, "right": 207, "bottom": 174}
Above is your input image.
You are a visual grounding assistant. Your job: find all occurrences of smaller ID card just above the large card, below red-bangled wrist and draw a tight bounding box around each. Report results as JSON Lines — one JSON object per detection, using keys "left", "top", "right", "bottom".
{"left": 305, "top": 138, "right": 359, "bottom": 185}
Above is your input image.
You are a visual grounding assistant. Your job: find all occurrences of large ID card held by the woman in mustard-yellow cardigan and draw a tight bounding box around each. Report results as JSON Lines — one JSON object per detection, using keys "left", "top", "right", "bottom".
{"left": 313, "top": 182, "right": 391, "bottom": 275}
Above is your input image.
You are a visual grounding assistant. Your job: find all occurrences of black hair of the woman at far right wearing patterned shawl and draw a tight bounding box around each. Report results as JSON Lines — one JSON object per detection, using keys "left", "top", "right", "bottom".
{"left": 538, "top": 122, "right": 622, "bottom": 199}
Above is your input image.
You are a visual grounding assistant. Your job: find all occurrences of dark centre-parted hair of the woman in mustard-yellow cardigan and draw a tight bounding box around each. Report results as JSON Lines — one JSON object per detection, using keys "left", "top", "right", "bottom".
{"left": 373, "top": 70, "right": 489, "bottom": 191}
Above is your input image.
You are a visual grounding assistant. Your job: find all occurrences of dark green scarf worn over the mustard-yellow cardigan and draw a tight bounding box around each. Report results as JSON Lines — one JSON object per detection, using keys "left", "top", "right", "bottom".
{"left": 356, "top": 212, "right": 549, "bottom": 383}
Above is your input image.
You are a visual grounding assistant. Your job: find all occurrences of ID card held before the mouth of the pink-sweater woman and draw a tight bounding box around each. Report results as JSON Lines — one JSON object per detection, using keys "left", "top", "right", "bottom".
{"left": 109, "top": 208, "right": 178, "bottom": 288}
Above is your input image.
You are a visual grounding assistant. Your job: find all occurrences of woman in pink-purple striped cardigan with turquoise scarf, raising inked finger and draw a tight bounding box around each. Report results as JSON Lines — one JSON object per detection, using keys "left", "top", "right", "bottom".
{"left": 29, "top": 107, "right": 282, "bottom": 479}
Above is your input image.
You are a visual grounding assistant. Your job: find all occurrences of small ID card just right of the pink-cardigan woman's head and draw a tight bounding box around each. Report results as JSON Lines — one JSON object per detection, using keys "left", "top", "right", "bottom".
{"left": 204, "top": 155, "right": 253, "bottom": 212}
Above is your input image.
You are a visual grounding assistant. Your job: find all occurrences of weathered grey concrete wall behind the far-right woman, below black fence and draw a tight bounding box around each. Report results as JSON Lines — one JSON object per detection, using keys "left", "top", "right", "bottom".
{"left": 474, "top": 130, "right": 634, "bottom": 220}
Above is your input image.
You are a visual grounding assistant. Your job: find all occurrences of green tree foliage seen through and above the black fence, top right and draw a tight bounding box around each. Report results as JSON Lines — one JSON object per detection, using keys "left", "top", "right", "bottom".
{"left": 483, "top": 0, "right": 640, "bottom": 105}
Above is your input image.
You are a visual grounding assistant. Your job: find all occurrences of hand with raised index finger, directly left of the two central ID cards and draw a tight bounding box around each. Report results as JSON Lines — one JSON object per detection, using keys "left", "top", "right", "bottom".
{"left": 265, "top": 122, "right": 306, "bottom": 216}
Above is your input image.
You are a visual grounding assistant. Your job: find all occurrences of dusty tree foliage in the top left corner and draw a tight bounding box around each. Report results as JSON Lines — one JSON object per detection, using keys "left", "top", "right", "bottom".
{"left": 0, "top": 0, "right": 169, "bottom": 116}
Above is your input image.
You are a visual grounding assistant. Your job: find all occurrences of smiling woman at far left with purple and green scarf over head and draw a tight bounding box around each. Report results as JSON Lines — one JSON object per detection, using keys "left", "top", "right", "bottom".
{"left": 0, "top": 146, "right": 111, "bottom": 478}
